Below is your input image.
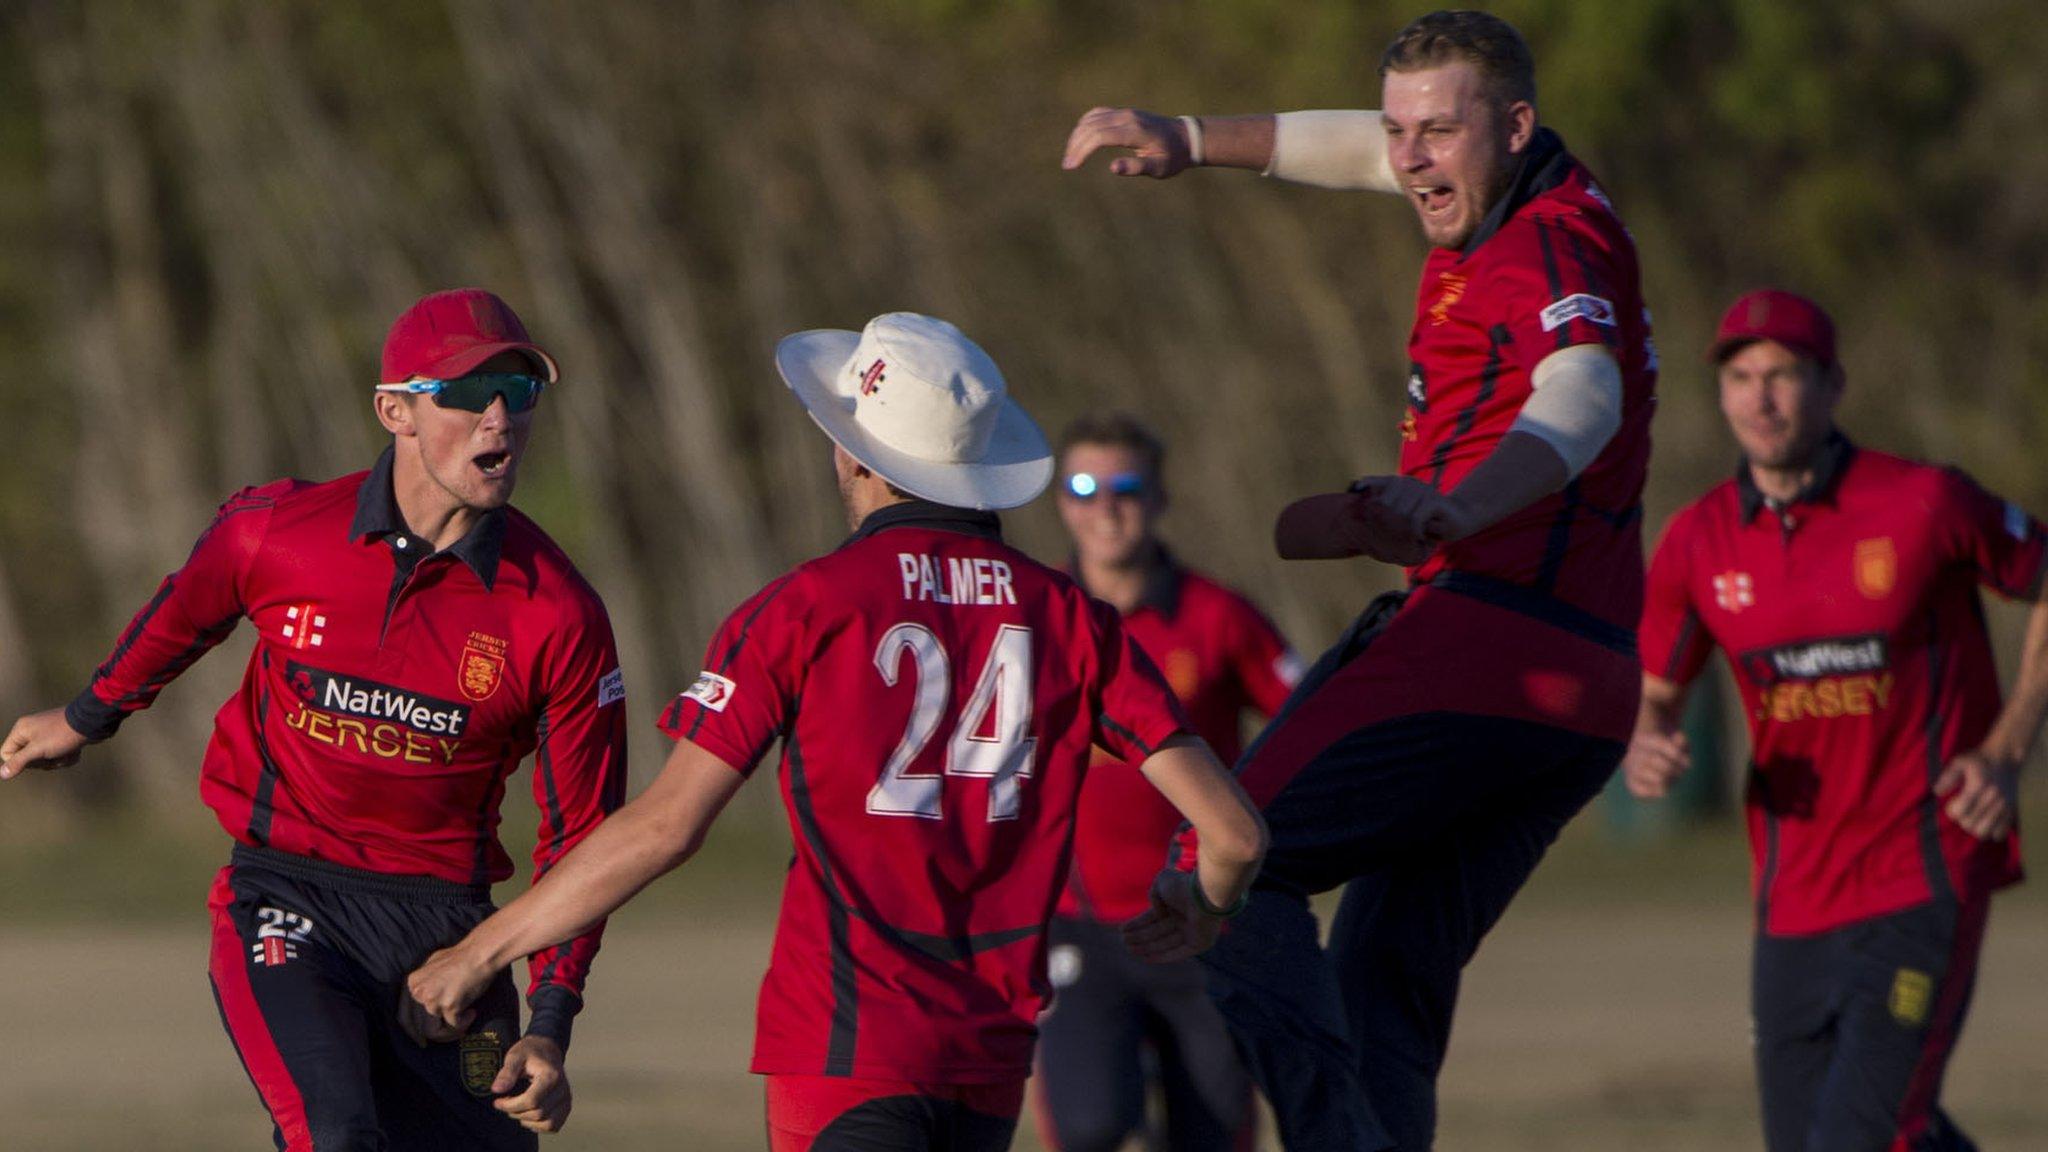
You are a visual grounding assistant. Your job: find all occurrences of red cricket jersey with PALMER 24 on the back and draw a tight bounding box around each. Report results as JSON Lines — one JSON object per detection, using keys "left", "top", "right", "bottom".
{"left": 662, "top": 502, "right": 1186, "bottom": 1082}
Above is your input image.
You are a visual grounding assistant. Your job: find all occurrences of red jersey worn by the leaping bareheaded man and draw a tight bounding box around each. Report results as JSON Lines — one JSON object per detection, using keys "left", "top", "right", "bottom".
{"left": 1401, "top": 129, "right": 1657, "bottom": 740}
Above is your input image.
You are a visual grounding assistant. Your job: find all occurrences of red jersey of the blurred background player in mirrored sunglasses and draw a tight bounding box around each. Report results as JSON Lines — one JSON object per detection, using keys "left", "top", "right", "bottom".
{"left": 1059, "top": 556, "right": 1300, "bottom": 922}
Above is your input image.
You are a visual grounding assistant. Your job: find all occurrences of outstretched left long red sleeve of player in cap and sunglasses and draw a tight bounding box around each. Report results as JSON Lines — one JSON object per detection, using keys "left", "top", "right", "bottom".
{"left": 63, "top": 480, "right": 293, "bottom": 740}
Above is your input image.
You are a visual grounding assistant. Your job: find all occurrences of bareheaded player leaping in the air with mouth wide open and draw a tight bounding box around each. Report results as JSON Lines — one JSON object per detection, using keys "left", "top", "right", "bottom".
{"left": 1065, "top": 12, "right": 1657, "bottom": 1150}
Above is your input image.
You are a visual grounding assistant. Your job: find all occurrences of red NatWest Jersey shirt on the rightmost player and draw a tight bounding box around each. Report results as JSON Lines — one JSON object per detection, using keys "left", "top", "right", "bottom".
{"left": 1642, "top": 437, "right": 2044, "bottom": 935}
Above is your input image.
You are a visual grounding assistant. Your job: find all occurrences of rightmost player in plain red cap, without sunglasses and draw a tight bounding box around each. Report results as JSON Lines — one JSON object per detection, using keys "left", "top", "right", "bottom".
{"left": 1624, "top": 291, "right": 2048, "bottom": 1152}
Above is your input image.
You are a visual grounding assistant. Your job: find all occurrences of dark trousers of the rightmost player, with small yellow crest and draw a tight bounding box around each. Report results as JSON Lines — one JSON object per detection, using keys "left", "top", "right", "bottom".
{"left": 1751, "top": 896, "right": 1989, "bottom": 1152}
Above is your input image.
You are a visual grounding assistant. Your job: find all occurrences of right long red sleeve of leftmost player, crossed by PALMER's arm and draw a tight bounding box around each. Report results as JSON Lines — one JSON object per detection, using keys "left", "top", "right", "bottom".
{"left": 526, "top": 588, "right": 627, "bottom": 1047}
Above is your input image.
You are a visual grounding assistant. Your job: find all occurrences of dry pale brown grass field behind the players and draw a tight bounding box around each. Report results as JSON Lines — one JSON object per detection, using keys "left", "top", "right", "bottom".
{"left": 0, "top": 811, "right": 2048, "bottom": 1152}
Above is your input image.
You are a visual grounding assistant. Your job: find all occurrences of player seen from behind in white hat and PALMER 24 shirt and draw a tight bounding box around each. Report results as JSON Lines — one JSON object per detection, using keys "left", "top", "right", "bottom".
{"left": 399, "top": 314, "right": 1264, "bottom": 1152}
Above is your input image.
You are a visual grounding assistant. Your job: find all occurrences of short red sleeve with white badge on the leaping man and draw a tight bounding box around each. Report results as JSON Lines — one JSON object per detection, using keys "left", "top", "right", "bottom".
{"left": 1495, "top": 217, "right": 1622, "bottom": 373}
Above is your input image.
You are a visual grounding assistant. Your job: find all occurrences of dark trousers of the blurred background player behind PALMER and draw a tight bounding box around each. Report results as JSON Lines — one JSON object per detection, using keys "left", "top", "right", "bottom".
{"left": 1038, "top": 918, "right": 1253, "bottom": 1152}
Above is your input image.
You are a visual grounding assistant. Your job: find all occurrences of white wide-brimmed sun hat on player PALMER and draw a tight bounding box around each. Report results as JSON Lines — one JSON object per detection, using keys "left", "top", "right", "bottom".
{"left": 774, "top": 312, "right": 1053, "bottom": 510}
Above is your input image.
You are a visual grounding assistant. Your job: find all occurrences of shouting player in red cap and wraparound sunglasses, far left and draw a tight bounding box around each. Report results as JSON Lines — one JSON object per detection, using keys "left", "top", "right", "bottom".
{"left": 0, "top": 289, "right": 625, "bottom": 1152}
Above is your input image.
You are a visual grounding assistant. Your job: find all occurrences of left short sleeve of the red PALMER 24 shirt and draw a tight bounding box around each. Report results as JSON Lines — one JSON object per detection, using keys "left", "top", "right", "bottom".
{"left": 659, "top": 574, "right": 805, "bottom": 775}
